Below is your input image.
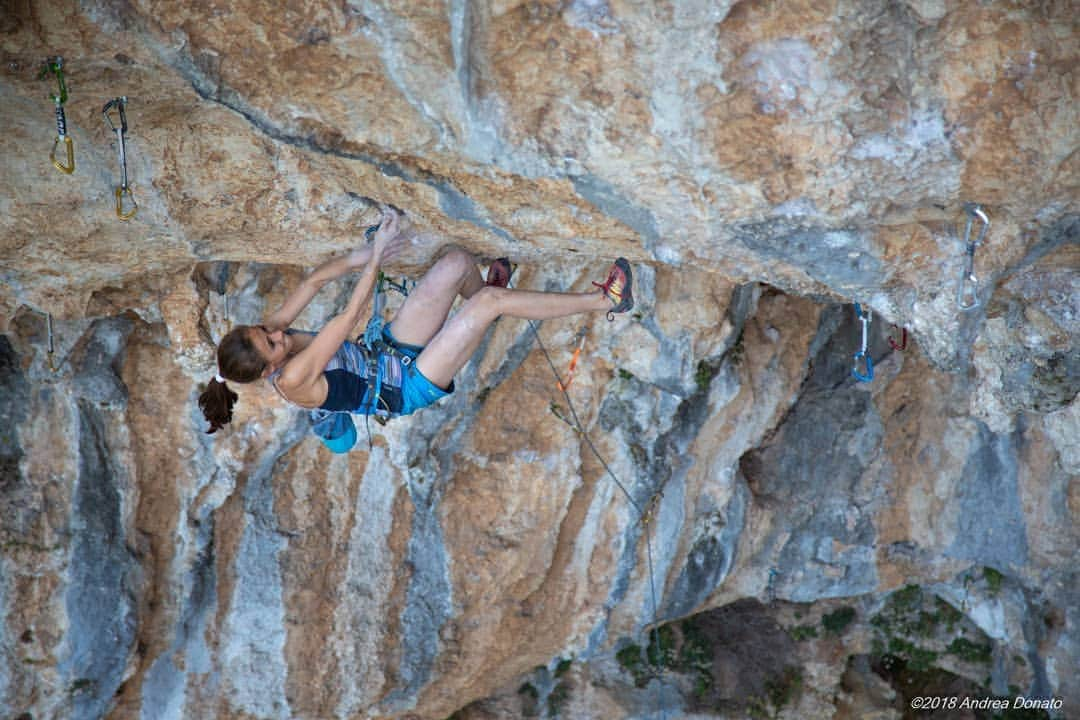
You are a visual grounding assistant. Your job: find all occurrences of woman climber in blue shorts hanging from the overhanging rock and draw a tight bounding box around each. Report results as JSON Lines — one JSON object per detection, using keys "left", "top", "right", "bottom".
{"left": 199, "top": 208, "right": 634, "bottom": 452}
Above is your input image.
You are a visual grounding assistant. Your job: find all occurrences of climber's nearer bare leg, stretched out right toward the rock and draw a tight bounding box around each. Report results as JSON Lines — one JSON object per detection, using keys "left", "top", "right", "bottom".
{"left": 416, "top": 286, "right": 611, "bottom": 388}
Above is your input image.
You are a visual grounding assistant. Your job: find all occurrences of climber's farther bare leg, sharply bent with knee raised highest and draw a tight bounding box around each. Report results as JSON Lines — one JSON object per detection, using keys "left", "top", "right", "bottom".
{"left": 390, "top": 247, "right": 484, "bottom": 347}
